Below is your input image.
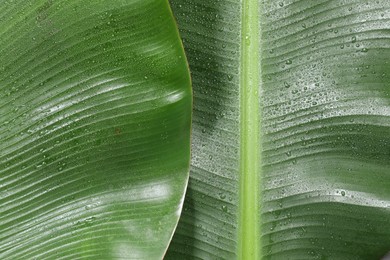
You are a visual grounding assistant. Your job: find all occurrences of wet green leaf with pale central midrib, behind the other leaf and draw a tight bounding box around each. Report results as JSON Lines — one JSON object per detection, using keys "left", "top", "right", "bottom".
{"left": 166, "top": 0, "right": 390, "bottom": 259}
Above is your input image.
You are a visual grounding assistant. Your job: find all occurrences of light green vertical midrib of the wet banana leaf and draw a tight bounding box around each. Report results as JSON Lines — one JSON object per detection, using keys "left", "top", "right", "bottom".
{"left": 238, "top": 0, "right": 261, "bottom": 260}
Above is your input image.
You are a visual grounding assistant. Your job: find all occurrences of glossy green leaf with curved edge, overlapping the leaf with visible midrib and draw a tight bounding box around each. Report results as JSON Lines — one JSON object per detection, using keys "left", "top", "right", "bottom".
{"left": 0, "top": 0, "right": 192, "bottom": 259}
